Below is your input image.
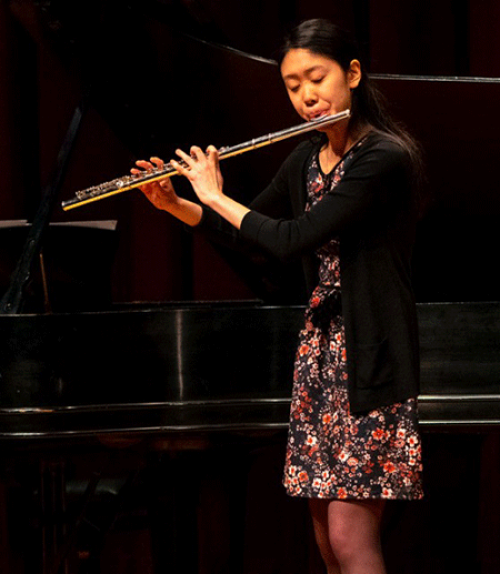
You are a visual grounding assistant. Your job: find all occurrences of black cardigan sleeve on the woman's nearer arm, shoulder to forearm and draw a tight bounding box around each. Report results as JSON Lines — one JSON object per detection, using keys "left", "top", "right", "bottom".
{"left": 240, "top": 140, "right": 406, "bottom": 260}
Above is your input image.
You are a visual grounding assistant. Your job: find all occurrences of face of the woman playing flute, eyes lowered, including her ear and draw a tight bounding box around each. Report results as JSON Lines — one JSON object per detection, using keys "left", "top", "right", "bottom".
{"left": 281, "top": 48, "right": 361, "bottom": 126}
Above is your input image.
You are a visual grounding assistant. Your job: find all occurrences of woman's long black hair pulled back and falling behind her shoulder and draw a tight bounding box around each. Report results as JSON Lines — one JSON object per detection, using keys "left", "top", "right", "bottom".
{"left": 278, "top": 18, "right": 423, "bottom": 206}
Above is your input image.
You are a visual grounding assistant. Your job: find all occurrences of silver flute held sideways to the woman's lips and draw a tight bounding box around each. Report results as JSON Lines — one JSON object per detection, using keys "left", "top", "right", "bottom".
{"left": 61, "top": 110, "right": 350, "bottom": 211}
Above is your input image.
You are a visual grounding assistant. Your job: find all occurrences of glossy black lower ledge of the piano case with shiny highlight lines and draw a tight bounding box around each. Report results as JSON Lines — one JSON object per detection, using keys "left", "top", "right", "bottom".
{"left": 0, "top": 394, "right": 500, "bottom": 441}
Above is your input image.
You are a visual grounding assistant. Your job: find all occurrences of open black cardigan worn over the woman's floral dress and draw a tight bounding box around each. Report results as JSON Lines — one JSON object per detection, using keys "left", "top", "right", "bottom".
{"left": 198, "top": 133, "right": 419, "bottom": 412}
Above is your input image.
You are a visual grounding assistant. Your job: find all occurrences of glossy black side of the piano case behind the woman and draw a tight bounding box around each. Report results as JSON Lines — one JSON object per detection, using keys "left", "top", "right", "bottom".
{"left": 0, "top": 301, "right": 500, "bottom": 441}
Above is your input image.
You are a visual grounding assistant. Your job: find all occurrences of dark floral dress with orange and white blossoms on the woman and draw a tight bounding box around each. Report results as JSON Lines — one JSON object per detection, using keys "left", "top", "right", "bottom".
{"left": 283, "top": 141, "right": 423, "bottom": 500}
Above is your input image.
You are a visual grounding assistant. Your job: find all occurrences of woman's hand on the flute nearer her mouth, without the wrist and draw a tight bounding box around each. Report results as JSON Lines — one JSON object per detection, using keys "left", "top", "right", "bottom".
{"left": 174, "top": 146, "right": 223, "bottom": 205}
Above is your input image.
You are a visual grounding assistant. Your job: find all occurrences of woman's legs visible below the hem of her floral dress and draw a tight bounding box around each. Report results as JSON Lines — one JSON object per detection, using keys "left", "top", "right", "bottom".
{"left": 310, "top": 500, "right": 386, "bottom": 574}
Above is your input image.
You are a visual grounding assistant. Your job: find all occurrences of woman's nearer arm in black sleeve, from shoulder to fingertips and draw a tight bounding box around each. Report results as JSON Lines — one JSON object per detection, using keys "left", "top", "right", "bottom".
{"left": 172, "top": 140, "right": 406, "bottom": 260}
